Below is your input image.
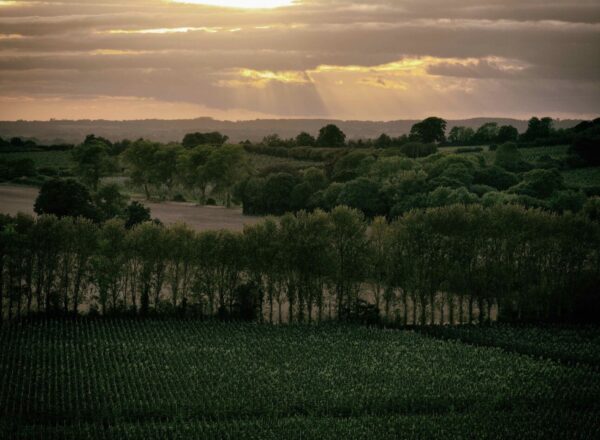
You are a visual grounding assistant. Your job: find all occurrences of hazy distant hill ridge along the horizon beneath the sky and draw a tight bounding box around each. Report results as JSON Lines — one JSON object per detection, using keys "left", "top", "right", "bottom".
{"left": 0, "top": 118, "right": 581, "bottom": 143}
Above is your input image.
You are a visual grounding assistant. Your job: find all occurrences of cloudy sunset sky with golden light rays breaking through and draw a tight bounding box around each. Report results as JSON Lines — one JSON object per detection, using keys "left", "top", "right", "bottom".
{"left": 0, "top": 0, "right": 600, "bottom": 120}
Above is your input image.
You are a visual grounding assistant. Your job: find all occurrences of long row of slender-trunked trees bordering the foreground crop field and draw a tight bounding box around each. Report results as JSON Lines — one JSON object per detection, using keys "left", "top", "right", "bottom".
{"left": 0, "top": 205, "right": 600, "bottom": 325}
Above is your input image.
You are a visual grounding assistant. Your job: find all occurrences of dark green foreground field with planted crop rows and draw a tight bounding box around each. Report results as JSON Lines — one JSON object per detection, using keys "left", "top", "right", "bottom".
{"left": 0, "top": 320, "right": 600, "bottom": 439}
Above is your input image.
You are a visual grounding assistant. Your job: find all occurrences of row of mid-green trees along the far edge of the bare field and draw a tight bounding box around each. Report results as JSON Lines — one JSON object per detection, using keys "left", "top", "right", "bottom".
{"left": 72, "top": 133, "right": 249, "bottom": 206}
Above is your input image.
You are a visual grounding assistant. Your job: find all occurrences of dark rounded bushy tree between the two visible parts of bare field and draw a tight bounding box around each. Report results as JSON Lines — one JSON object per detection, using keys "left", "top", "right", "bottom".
{"left": 33, "top": 179, "right": 98, "bottom": 219}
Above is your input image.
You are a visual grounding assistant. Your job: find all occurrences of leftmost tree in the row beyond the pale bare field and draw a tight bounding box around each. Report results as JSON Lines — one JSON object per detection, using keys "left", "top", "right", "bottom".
{"left": 72, "top": 140, "right": 115, "bottom": 191}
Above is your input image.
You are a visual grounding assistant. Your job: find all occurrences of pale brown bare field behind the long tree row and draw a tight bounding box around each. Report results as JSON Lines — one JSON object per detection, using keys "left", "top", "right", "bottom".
{"left": 0, "top": 185, "right": 261, "bottom": 231}
